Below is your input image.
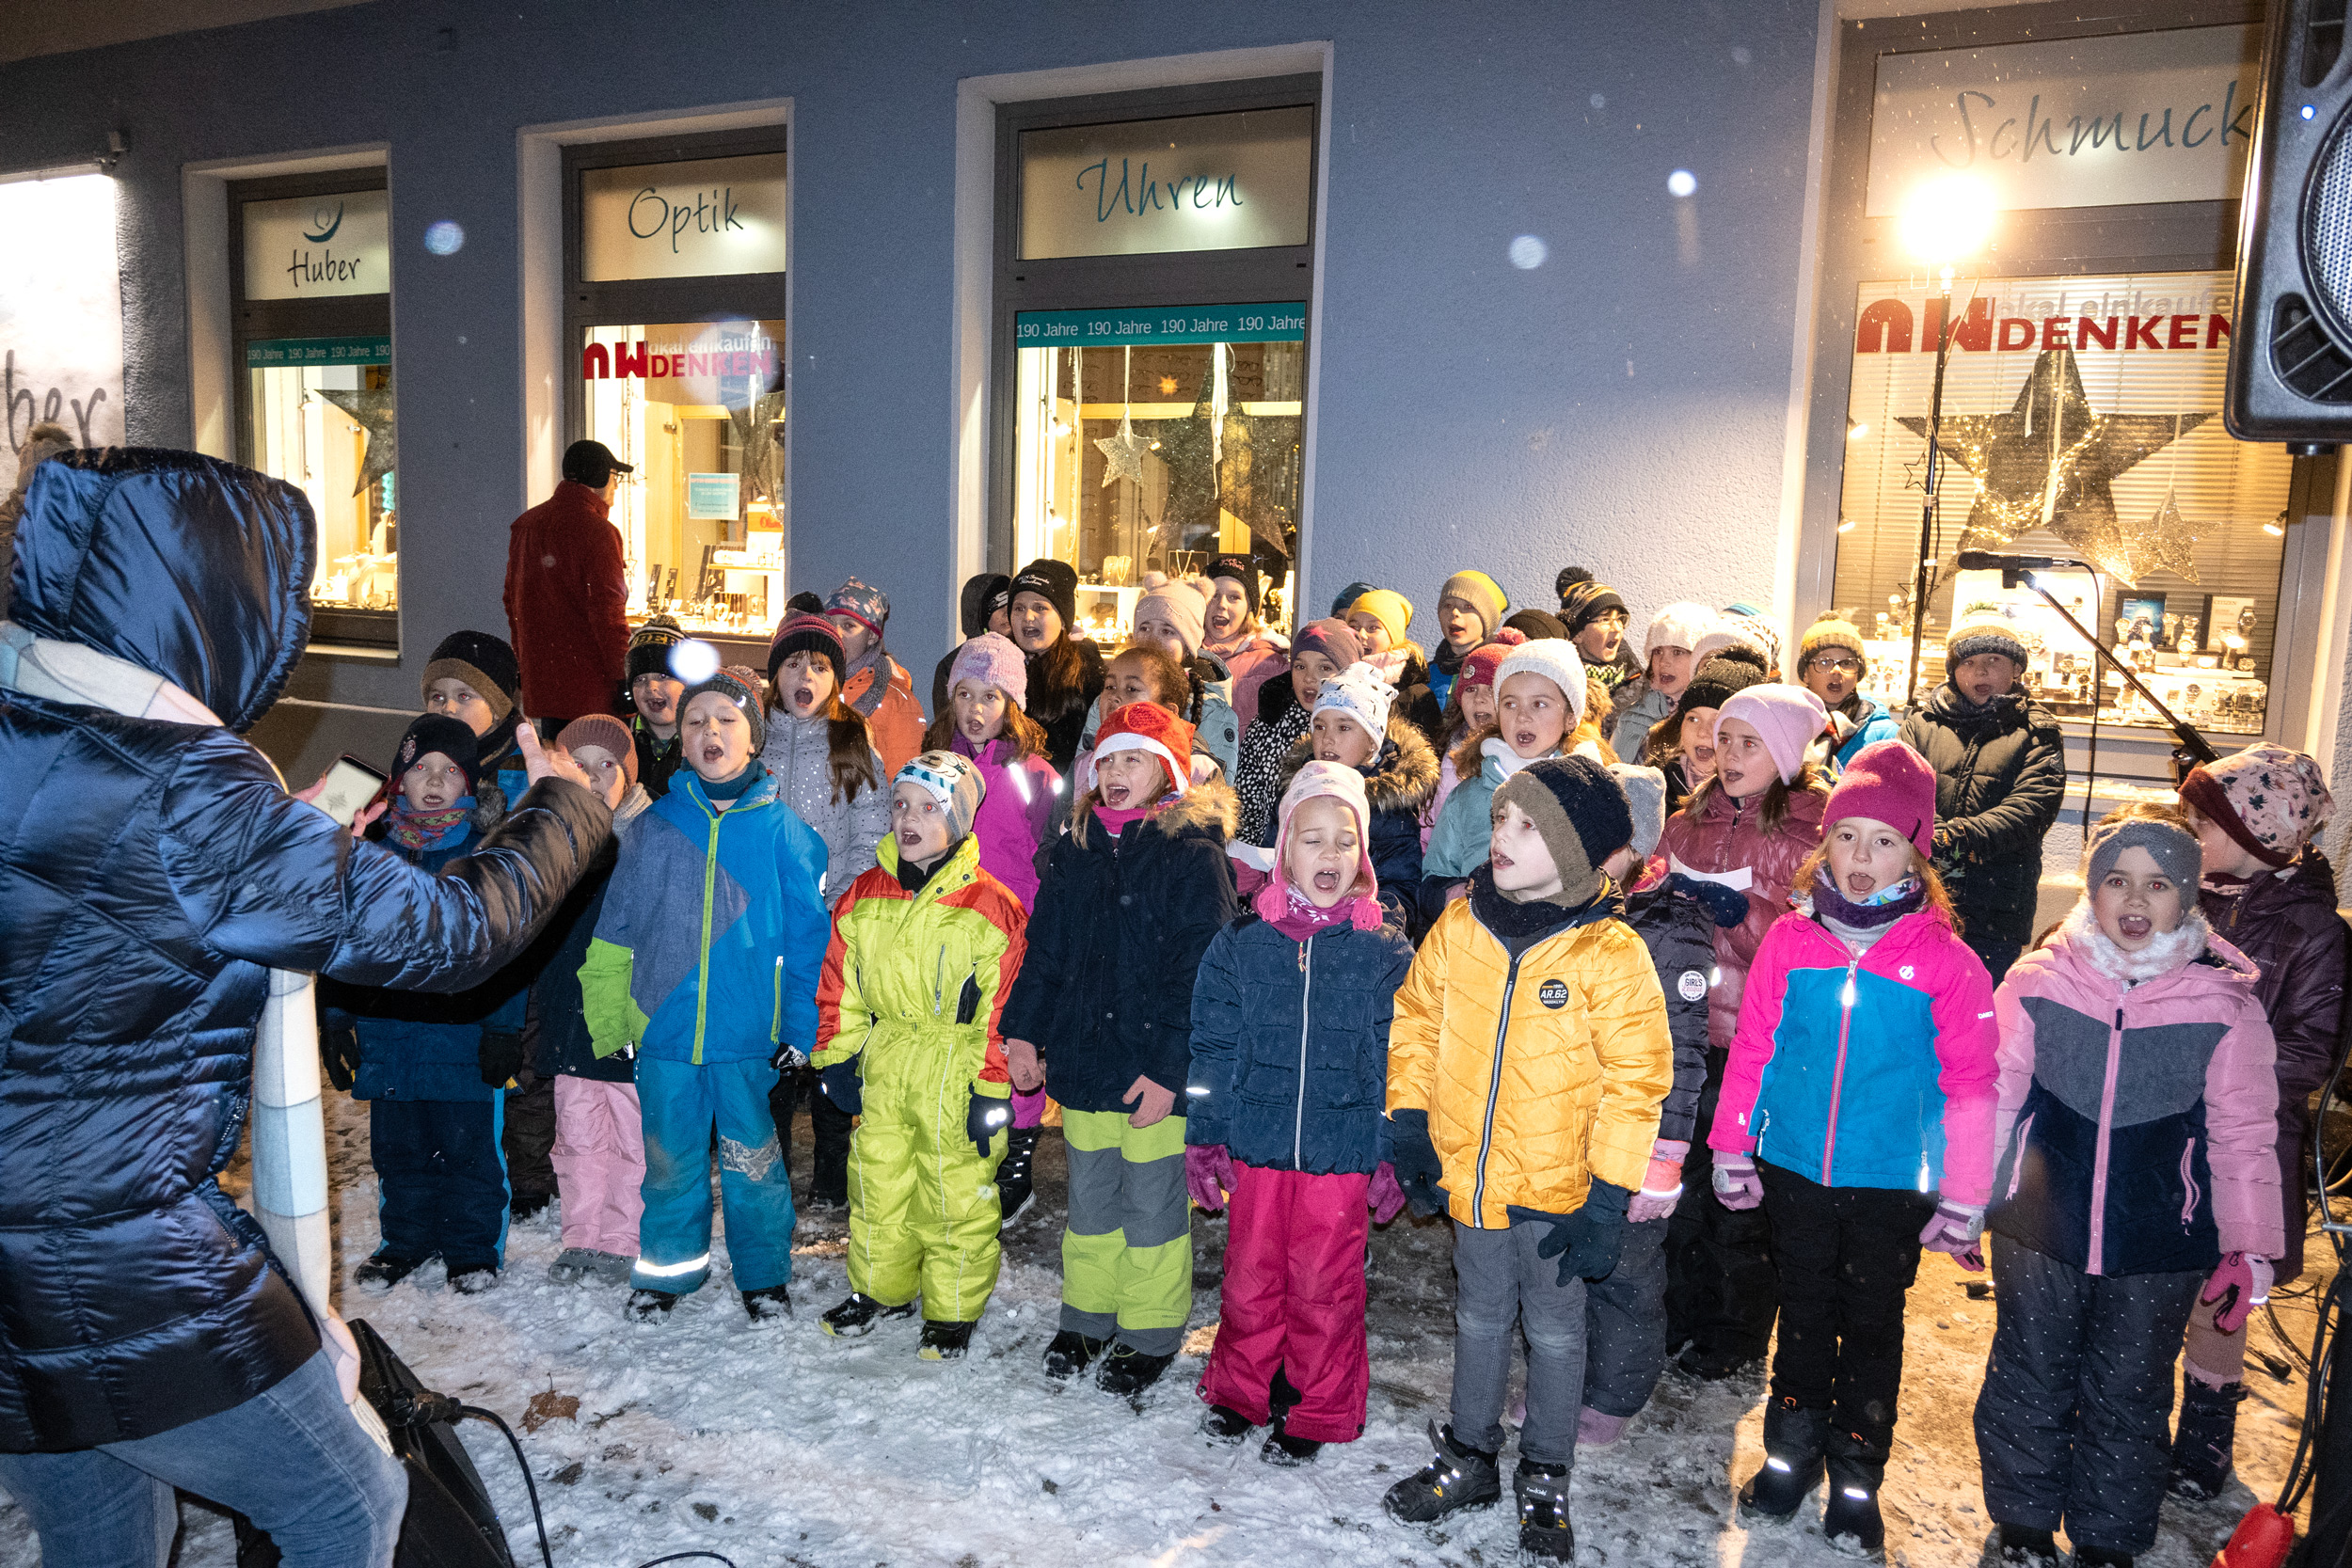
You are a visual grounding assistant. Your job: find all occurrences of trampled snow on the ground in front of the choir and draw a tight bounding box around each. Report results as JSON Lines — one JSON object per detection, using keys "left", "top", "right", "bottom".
{"left": 0, "top": 1091, "right": 2327, "bottom": 1568}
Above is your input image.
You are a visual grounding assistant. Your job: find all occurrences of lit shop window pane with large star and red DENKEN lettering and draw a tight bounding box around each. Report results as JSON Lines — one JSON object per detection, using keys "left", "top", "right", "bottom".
{"left": 1835, "top": 270, "right": 2294, "bottom": 736}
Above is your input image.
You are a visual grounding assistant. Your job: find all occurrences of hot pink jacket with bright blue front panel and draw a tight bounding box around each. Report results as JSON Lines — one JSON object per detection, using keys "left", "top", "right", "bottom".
{"left": 1708, "top": 908, "right": 1997, "bottom": 1206}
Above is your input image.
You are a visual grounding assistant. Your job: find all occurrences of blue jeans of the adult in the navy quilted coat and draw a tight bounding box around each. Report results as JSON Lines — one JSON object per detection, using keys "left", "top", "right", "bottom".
{"left": 0, "top": 1352, "right": 409, "bottom": 1568}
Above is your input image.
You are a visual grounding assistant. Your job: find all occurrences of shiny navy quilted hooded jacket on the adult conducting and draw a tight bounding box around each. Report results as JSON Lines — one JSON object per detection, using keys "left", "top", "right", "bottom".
{"left": 0, "top": 449, "right": 612, "bottom": 1453}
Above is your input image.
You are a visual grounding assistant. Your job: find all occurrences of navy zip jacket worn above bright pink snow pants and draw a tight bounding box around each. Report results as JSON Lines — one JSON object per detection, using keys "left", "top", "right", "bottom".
{"left": 1185, "top": 914, "right": 1414, "bottom": 1176}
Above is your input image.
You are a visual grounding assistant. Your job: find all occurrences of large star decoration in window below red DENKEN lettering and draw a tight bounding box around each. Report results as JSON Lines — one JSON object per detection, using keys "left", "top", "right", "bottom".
{"left": 1899, "top": 348, "right": 2214, "bottom": 583}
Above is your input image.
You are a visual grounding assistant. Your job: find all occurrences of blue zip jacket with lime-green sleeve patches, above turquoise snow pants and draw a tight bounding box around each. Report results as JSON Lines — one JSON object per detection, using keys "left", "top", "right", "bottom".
{"left": 581, "top": 768, "right": 833, "bottom": 1063}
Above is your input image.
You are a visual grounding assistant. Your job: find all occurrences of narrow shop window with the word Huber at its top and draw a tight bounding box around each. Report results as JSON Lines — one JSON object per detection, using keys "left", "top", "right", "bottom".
{"left": 230, "top": 171, "right": 400, "bottom": 649}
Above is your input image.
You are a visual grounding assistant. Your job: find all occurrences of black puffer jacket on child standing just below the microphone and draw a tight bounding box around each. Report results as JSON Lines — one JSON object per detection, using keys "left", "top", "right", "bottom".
{"left": 1903, "top": 682, "right": 2065, "bottom": 947}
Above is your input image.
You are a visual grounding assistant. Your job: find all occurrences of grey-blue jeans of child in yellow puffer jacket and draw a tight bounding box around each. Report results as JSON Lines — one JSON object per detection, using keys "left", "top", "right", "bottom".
{"left": 1452, "top": 1220, "right": 1585, "bottom": 1465}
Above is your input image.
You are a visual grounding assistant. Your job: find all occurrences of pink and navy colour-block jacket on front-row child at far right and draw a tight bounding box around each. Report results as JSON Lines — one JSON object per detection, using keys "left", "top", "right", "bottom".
{"left": 1985, "top": 900, "right": 2286, "bottom": 1275}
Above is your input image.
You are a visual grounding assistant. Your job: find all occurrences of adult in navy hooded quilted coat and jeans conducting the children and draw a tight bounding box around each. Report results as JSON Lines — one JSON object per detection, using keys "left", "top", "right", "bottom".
{"left": 0, "top": 449, "right": 612, "bottom": 1566}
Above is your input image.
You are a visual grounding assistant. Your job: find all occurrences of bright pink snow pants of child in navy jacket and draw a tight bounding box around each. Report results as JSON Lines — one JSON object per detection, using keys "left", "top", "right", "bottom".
{"left": 1200, "top": 1162, "right": 1372, "bottom": 1444}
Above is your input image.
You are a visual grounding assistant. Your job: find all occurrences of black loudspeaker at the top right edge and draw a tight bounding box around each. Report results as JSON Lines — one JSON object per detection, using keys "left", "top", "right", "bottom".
{"left": 2223, "top": 0, "right": 2352, "bottom": 447}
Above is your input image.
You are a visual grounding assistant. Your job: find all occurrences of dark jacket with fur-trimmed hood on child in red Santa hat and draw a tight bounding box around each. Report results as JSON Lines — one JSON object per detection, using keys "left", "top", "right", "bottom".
{"left": 997, "top": 783, "right": 1242, "bottom": 1115}
